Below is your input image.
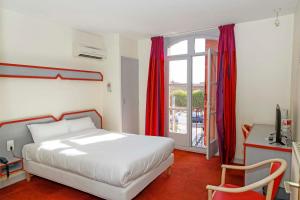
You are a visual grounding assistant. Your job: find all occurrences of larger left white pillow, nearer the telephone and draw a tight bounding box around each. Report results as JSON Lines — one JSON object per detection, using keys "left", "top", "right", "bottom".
{"left": 27, "top": 120, "right": 69, "bottom": 143}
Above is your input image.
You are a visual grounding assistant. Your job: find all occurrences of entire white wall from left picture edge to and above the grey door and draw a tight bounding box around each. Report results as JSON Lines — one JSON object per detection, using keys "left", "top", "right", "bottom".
{"left": 0, "top": 10, "right": 130, "bottom": 131}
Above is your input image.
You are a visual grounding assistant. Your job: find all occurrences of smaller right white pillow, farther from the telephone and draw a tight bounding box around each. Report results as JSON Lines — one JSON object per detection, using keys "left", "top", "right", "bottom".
{"left": 66, "top": 117, "right": 96, "bottom": 132}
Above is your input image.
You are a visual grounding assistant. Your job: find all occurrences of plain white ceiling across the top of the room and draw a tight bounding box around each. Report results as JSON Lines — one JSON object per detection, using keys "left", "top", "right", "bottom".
{"left": 0, "top": 0, "right": 297, "bottom": 37}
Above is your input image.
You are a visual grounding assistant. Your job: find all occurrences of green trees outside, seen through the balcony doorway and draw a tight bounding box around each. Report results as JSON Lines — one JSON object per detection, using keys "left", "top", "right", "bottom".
{"left": 172, "top": 90, "right": 204, "bottom": 110}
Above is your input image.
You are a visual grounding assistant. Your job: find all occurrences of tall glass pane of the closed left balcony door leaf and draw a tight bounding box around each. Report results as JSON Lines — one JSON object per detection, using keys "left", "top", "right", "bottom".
{"left": 169, "top": 60, "right": 188, "bottom": 134}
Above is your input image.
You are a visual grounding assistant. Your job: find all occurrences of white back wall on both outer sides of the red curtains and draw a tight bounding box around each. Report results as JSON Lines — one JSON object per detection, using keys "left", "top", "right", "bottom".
{"left": 138, "top": 15, "right": 293, "bottom": 160}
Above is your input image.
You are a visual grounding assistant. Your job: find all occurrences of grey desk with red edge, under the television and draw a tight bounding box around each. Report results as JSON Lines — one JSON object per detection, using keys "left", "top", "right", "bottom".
{"left": 244, "top": 124, "right": 292, "bottom": 191}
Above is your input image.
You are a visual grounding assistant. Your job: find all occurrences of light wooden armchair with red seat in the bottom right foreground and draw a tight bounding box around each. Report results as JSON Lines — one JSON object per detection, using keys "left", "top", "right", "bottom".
{"left": 206, "top": 159, "right": 287, "bottom": 200}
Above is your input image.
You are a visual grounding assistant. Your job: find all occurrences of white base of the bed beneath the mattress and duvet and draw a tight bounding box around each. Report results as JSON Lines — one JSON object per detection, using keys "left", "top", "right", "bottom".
{"left": 24, "top": 153, "right": 174, "bottom": 200}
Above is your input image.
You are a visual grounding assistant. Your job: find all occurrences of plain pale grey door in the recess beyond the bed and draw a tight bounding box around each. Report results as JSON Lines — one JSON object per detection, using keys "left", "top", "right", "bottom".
{"left": 121, "top": 57, "right": 139, "bottom": 134}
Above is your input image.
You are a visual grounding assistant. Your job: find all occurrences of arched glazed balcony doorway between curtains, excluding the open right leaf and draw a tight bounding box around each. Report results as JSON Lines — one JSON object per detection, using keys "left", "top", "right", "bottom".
{"left": 166, "top": 36, "right": 218, "bottom": 148}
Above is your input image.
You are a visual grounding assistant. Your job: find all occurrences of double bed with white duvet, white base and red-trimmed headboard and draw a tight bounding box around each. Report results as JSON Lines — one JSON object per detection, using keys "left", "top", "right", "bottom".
{"left": 0, "top": 110, "right": 174, "bottom": 200}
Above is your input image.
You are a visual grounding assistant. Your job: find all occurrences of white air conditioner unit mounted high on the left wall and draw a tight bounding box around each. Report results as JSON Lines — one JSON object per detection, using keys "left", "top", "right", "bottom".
{"left": 73, "top": 31, "right": 106, "bottom": 60}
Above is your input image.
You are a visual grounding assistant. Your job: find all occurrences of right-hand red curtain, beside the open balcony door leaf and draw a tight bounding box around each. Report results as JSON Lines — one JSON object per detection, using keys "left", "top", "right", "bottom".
{"left": 217, "top": 24, "right": 236, "bottom": 164}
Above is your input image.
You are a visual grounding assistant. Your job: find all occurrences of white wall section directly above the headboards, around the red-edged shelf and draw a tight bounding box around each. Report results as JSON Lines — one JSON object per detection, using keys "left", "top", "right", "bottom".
{"left": 0, "top": 10, "right": 106, "bottom": 121}
